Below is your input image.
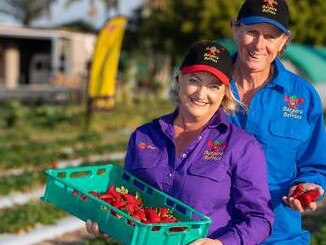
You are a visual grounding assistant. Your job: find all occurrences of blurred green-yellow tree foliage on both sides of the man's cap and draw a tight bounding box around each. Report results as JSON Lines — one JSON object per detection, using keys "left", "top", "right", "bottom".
{"left": 137, "top": 0, "right": 326, "bottom": 61}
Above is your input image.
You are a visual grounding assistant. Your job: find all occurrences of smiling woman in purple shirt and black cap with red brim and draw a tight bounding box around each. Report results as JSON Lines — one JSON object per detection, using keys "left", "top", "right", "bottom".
{"left": 87, "top": 41, "right": 274, "bottom": 245}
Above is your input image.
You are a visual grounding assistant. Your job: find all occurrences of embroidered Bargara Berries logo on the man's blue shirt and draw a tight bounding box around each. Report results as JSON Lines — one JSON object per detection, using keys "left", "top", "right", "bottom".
{"left": 282, "top": 95, "right": 304, "bottom": 119}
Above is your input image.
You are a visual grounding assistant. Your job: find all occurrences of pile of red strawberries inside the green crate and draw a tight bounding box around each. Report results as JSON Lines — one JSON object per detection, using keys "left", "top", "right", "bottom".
{"left": 85, "top": 185, "right": 183, "bottom": 231}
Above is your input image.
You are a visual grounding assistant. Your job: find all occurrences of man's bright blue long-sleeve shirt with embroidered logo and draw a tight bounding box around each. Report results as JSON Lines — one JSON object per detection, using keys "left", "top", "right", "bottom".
{"left": 229, "top": 59, "right": 326, "bottom": 245}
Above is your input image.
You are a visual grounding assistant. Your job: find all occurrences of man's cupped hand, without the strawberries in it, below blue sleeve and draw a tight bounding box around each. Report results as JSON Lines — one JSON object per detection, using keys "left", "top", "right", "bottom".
{"left": 282, "top": 183, "right": 324, "bottom": 213}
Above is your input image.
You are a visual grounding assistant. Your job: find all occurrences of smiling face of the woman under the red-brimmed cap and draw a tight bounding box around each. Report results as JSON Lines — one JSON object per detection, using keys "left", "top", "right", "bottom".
{"left": 179, "top": 72, "right": 226, "bottom": 121}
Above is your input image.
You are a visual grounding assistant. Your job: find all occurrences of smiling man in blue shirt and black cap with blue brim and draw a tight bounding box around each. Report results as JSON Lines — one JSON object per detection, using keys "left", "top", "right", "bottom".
{"left": 230, "top": 0, "right": 326, "bottom": 245}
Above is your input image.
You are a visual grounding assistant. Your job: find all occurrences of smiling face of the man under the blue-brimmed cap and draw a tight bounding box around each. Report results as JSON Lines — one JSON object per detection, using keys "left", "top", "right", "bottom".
{"left": 233, "top": 23, "right": 288, "bottom": 72}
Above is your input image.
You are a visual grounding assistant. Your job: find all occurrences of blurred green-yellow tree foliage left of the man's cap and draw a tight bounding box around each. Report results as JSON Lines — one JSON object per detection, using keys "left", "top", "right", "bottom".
{"left": 139, "top": 0, "right": 243, "bottom": 60}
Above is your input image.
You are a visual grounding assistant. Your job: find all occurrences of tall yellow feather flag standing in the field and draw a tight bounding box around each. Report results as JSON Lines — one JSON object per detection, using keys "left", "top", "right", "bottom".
{"left": 88, "top": 16, "right": 127, "bottom": 109}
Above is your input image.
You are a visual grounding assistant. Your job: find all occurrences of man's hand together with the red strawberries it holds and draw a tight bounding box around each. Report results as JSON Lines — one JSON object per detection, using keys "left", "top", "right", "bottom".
{"left": 283, "top": 183, "right": 324, "bottom": 212}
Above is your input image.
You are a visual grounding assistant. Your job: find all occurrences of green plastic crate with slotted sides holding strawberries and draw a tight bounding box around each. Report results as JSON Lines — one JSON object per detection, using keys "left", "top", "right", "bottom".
{"left": 41, "top": 164, "right": 211, "bottom": 245}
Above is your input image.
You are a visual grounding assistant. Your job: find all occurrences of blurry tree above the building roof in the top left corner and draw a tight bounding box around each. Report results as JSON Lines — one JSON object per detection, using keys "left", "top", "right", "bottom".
{"left": 0, "top": 0, "right": 56, "bottom": 26}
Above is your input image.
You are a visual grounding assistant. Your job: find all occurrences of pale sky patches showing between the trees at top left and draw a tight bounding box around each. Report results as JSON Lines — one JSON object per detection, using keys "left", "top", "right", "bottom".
{"left": 0, "top": 0, "right": 142, "bottom": 27}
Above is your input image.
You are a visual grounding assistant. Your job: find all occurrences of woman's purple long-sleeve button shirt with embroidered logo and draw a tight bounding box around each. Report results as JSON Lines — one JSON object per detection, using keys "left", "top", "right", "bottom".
{"left": 125, "top": 110, "right": 274, "bottom": 245}
